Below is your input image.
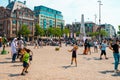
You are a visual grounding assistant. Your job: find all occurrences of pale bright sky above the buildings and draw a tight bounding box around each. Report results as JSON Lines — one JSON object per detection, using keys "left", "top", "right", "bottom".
{"left": 0, "top": 0, "right": 120, "bottom": 31}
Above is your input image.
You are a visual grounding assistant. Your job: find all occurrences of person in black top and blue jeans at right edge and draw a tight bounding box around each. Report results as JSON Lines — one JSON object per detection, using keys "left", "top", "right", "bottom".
{"left": 109, "top": 41, "right": 120, "bottom": 72}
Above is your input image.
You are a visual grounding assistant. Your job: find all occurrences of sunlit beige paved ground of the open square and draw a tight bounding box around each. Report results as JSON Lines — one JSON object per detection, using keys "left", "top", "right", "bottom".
{"left": 0, "top": 44, "right": 120, "bottom": 80}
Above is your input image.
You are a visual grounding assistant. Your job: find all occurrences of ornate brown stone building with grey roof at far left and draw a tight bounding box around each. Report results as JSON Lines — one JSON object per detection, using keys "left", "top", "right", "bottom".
{"left": 0, "top": 0, "right": 35, "bottom": 38}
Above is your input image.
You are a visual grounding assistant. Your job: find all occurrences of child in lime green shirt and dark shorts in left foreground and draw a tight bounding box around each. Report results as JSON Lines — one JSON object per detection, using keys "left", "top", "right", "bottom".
{"left": 20, "top": 49, "right": 30, "bottom": 75}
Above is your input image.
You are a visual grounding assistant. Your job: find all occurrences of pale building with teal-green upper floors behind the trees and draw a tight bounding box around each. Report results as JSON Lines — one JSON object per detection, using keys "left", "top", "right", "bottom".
{"left": 34, "top": 6, "right": 64, "bottom": 29}
